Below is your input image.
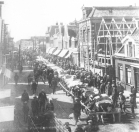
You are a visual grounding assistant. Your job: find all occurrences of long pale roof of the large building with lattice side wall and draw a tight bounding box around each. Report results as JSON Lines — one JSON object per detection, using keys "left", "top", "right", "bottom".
{"left": 88, "top": 6, "right": 139, "bottom": 17}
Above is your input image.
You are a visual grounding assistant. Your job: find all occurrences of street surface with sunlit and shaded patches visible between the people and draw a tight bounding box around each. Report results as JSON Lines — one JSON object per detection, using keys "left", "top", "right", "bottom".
{"left": 0, "top": 53, "right": 139, "bottom": 132}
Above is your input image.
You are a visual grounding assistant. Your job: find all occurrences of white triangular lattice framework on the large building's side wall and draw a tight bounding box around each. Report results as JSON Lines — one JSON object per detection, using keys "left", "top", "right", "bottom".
{"left": 97, "top": 17, "right": 137, "bottom": 65}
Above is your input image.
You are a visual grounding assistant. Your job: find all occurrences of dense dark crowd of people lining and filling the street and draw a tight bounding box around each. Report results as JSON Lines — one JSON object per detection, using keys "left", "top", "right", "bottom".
{"left": 14, "top": 50, "right": 136, "bottom": 132}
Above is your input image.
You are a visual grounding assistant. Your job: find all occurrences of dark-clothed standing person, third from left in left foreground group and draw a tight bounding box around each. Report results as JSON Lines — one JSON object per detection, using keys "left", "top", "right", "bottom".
{"left": 38, "top": 89, "right": 48, "bottom": 112}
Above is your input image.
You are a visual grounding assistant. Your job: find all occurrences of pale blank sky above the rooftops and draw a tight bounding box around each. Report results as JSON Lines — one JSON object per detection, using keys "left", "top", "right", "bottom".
{"left": 1, "top": 0, "right": 139, "bottom": 41}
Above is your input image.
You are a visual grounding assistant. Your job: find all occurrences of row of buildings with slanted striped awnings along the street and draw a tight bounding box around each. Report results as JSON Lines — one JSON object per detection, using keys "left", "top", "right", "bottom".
{"left": 46, "top": 21, "right": 78, "bottom": 65}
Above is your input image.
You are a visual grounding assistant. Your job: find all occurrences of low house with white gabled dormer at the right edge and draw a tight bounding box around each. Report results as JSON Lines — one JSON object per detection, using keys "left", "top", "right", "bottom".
{"left": 114, "top": 29, "right": 139, "bottom": 91}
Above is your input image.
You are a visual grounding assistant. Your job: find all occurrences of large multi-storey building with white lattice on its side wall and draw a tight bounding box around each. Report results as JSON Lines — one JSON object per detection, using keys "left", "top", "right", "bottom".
{"left": 79, "top": 6, "right": 139, "bottom": 74}
